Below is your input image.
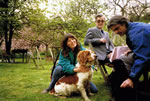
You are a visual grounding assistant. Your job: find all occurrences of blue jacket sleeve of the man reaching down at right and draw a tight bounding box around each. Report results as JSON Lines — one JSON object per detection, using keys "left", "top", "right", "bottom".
{"left": 129, "top": 28, "right": 150, "bottom": 79}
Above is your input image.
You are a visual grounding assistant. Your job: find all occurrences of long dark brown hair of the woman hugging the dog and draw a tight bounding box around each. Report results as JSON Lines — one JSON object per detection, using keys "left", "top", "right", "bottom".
{"left": 61, "top": 34, "right": 80, "bottom": 57}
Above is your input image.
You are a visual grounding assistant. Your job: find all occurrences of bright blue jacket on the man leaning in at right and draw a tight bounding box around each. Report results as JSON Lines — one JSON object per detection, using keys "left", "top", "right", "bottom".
{"left": 126, "top": 22, "right": 150, "bottom": 78}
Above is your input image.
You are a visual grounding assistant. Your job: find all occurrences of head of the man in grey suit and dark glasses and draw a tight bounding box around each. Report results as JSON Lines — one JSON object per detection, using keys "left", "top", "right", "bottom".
{"left": 95, "top": 14, "right": 105, "bottom": 29}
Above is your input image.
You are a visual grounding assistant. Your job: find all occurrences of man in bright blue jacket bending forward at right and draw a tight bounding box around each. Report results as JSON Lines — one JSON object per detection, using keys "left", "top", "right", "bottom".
{"left": 107, "top": 15, "right": 150, "bottom": 88}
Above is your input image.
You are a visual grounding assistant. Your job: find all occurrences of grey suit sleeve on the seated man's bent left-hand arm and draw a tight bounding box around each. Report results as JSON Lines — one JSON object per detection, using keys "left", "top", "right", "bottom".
{"left": 84, "top": 29, "right": 103, "bottom": 46}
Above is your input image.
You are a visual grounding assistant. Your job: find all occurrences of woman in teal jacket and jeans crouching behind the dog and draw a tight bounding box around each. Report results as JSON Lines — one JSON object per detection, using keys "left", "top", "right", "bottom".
{"left": 42, "top": 34, "right": 98, "bottom": 93}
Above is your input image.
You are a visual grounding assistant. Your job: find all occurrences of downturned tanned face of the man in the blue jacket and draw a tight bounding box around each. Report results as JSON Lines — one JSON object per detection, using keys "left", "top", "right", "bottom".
{"left": 111, "top": 24, "right": 127, "bottom": 36}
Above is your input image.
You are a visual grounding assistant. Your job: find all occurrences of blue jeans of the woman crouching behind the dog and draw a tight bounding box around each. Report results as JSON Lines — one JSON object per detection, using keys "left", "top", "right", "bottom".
{"left": 47, "top": 66, "right": 98, "bottom": 93}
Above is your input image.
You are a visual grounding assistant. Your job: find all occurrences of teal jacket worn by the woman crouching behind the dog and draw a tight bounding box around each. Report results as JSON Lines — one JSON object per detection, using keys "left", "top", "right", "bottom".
{"left": 57, "top": 46, "right": 85, "bottom": 74}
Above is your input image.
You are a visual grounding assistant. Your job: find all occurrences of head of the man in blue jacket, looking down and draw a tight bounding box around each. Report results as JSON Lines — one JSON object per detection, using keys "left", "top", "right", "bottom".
{"left": 107, "top": 15, "right": 129, "bottom": 36}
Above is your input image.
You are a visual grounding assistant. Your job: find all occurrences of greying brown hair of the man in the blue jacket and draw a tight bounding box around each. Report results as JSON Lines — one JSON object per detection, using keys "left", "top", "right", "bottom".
{"left": 107, "top": 15, "right": 129, "bottom": 29}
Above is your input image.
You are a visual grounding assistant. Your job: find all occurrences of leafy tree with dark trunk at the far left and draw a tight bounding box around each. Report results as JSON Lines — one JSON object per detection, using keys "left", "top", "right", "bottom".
{"left": 0, "top": 0, "right": 47, "bottom": 55}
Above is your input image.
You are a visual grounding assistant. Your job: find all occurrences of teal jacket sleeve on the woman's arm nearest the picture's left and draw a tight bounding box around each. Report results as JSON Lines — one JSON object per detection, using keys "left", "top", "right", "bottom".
{"left": 58, "top": 53, "right": 75, "bottom": 74}
